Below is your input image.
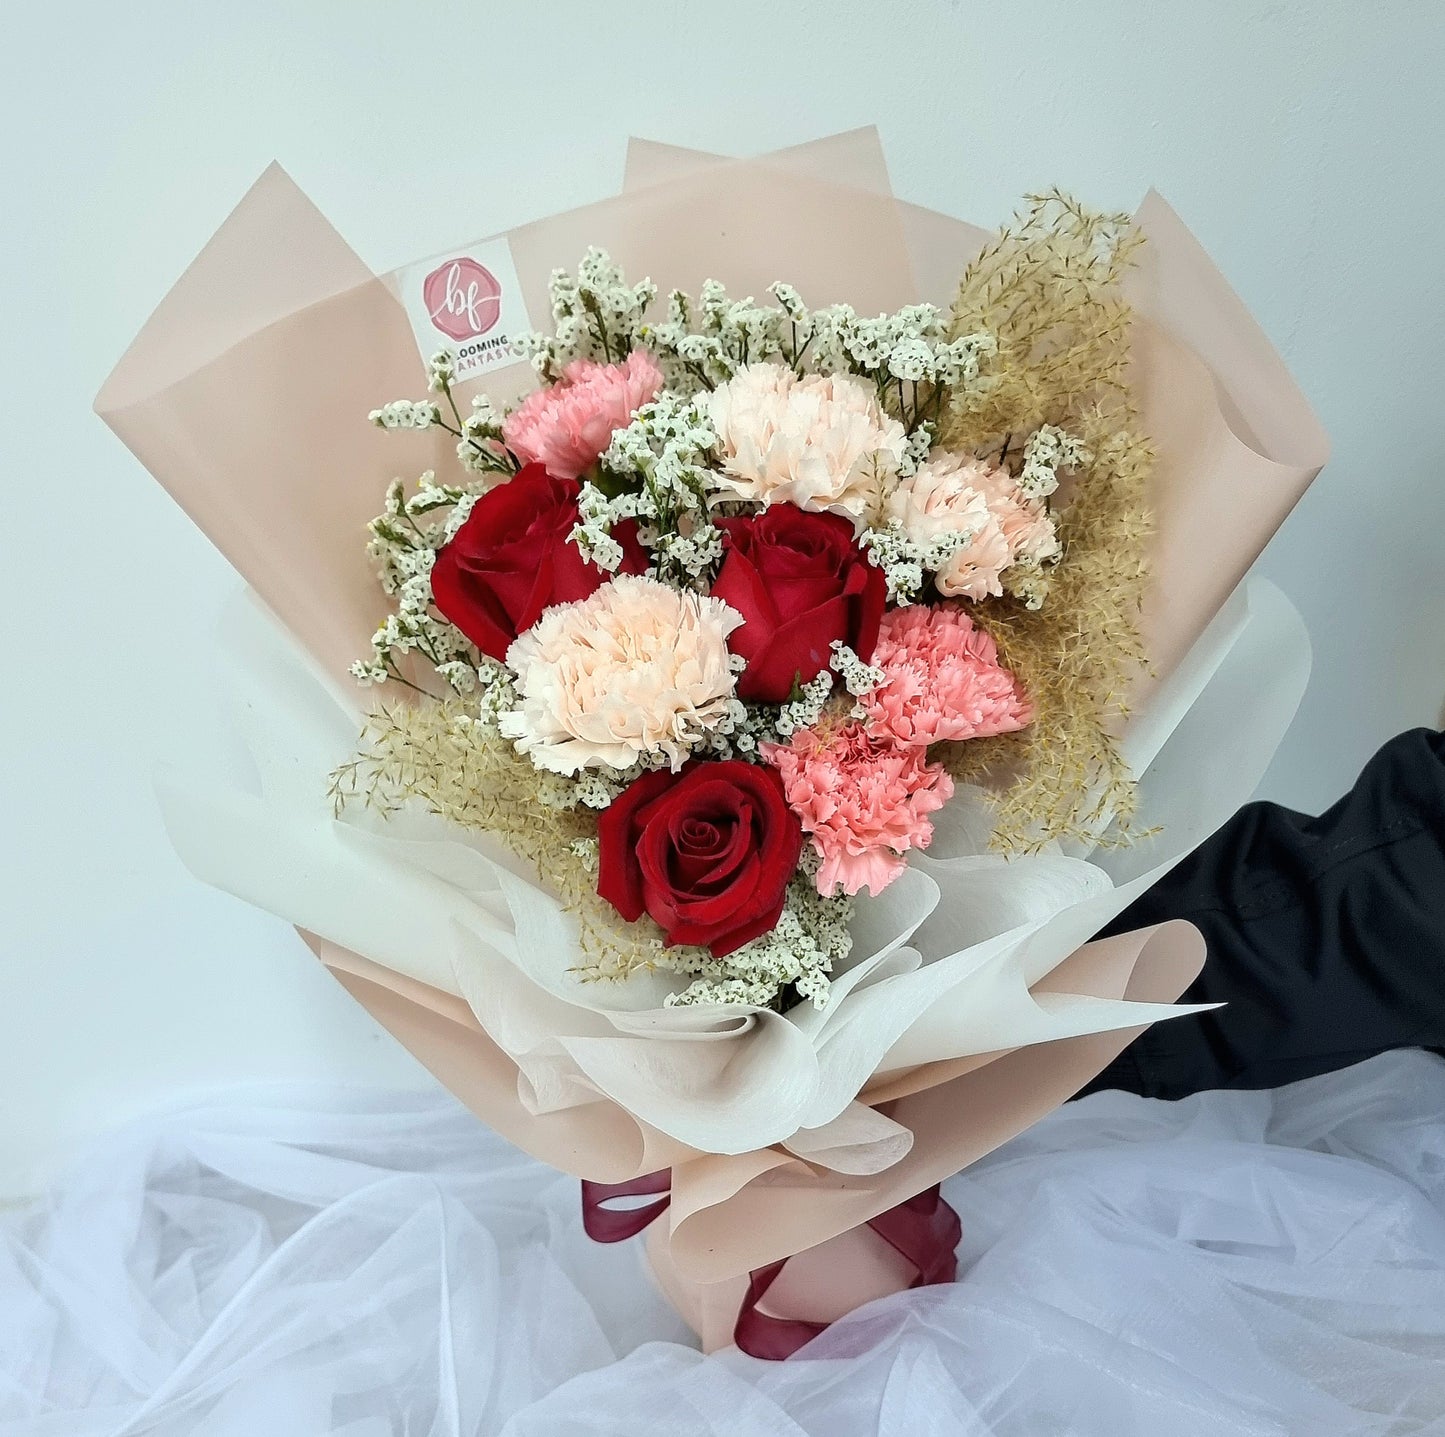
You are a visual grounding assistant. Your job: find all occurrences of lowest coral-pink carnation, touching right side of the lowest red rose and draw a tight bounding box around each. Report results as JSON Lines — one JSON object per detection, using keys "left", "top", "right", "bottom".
{"left": 763, "top": 723, "right": 954, "bottom": 896}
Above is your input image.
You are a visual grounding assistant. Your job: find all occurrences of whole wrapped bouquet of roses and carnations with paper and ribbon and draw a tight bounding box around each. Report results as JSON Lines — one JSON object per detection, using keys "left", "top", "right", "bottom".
{"left": 97, "top": 132, "right": 1325, "bottom": 1356}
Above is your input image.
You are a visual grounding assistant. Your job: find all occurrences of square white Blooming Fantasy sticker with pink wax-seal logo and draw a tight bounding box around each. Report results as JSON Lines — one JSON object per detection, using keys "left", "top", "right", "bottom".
{"left": 402, "top": 239, "right": 532, "bottom": 382}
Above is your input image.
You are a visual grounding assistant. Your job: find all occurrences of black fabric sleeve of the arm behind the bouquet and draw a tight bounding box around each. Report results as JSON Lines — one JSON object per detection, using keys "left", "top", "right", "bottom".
{"left": 1085, "top": 729, "right": 1445, "bottom": 1099}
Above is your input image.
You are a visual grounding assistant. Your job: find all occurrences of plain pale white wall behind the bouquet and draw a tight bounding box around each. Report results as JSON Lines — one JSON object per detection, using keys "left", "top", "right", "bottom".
{"left": 0, "top": 0, "right": 1445, "bottom": 1194}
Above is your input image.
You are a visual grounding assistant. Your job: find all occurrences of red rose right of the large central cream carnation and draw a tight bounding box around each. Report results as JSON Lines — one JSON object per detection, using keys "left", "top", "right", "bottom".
{"left": 712, "top": 505, "right": 887, "bottom": 704}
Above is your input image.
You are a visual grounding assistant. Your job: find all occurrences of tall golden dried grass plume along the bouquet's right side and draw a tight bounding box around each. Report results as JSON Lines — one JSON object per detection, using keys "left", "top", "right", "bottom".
{"left": 941, "top": 191, "right": 1153, "bottom": 852}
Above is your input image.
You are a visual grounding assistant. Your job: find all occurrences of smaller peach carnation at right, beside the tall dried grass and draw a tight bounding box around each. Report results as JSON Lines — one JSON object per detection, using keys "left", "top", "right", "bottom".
{"left": 886, "top": 454, "right": 1059, "bottom": 600}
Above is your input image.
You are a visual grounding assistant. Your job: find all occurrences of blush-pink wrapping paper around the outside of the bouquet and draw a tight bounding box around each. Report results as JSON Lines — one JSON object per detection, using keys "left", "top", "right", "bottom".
{"left": 97, "top": 132, "right": 1327, "bottom": 1344}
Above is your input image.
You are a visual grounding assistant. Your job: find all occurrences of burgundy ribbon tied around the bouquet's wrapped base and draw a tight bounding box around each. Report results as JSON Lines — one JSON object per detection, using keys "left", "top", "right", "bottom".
{"left": 582, "top": 1168, "right": 962, "bottom": 1362}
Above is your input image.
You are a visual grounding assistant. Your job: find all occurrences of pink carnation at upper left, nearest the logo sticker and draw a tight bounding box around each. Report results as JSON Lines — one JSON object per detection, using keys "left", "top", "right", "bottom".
{"left": 501, "top": 350, "right": 662, "bottom": 479}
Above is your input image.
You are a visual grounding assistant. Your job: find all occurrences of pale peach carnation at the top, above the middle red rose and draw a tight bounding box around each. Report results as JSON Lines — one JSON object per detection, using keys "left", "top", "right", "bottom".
{"left": 708, "top": 364, "right": 906, "bottom": 528}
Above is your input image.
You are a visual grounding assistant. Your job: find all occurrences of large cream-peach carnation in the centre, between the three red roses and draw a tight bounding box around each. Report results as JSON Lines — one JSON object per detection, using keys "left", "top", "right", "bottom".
{"left": 500, "top": 574, "right": 743, "bottom": 773}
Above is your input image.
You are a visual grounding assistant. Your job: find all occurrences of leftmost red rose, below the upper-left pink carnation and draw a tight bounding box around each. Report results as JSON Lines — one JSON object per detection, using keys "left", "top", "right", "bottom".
{"left": 432, "top": 464, "right": 647, "bottom": 661}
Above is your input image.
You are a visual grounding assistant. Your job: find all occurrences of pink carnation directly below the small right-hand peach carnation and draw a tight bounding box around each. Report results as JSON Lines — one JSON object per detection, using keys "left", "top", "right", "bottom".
{"left": 860, "top": 604, "right": 1033, "bottom": 747}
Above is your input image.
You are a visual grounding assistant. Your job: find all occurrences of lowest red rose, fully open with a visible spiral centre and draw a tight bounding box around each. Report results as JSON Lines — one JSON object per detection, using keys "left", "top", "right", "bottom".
{"left": 597, "top": 759, "right": 803, "bottom": 958}
